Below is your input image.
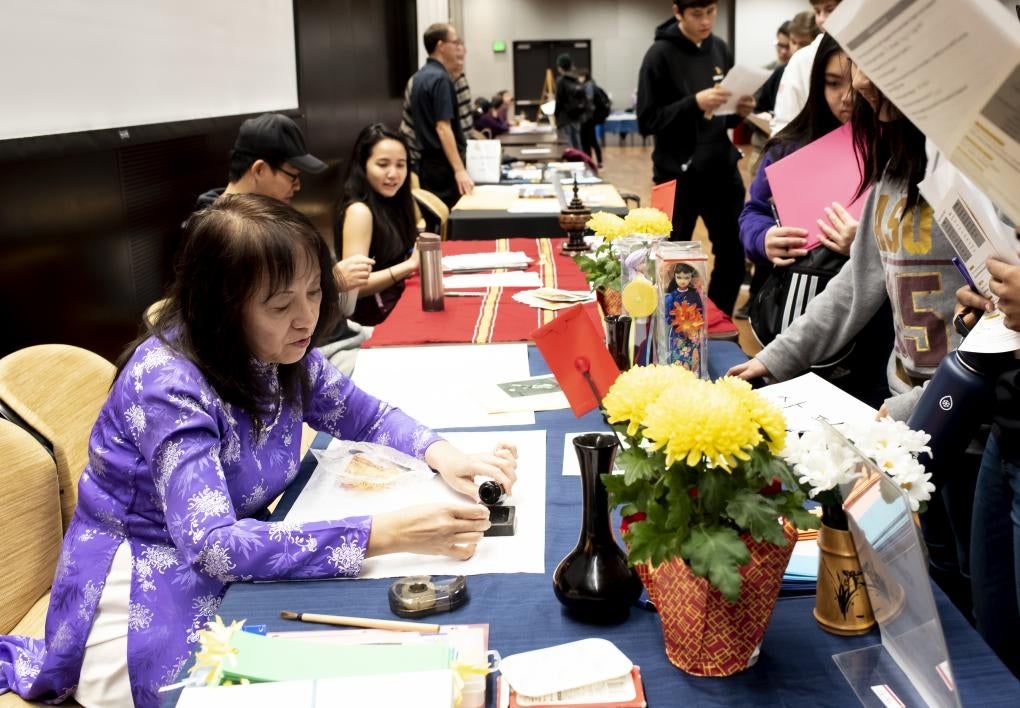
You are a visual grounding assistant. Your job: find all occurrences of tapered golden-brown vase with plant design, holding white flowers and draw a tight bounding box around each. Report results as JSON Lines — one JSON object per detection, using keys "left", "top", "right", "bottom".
{"left": 814, "top": 521, "right": 875, "bottom": 637}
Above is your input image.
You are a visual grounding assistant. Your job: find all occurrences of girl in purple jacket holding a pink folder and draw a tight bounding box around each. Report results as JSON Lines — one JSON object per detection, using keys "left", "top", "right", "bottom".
{"left": 741, "top": 36, "right": 891, "bottom": 407}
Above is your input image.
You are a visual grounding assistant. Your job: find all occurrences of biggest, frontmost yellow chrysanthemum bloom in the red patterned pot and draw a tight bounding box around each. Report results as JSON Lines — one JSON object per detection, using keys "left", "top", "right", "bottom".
{"left": 644, "top": 380, "right": 762, "bottom": 470}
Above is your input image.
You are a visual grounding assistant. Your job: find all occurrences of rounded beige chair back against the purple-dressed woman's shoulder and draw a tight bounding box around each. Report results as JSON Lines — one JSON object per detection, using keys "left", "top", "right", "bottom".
{"left": 0, "top": 344, "right": 116, "bottom": 529}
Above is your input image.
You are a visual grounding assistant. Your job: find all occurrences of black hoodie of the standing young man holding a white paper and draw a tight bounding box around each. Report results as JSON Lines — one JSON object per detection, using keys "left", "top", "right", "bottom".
{"left": 638, "top": 19, "right": 741, "bottom": 182}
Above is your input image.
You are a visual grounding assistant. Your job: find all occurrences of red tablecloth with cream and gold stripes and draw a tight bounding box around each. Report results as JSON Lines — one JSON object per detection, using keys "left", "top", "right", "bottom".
{"left": 362, "top": 239, "right": 736, "bottom": 347}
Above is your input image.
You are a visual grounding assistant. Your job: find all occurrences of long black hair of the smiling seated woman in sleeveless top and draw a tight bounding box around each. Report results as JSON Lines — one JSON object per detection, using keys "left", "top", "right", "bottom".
{"left": 335, "top": 122, "right": 417, "bottom": 262}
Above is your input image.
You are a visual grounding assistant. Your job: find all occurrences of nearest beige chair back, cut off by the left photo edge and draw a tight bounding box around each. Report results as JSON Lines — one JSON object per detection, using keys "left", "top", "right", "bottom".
{"left": 0, "top": 418, "right": 63, "bottom": 669}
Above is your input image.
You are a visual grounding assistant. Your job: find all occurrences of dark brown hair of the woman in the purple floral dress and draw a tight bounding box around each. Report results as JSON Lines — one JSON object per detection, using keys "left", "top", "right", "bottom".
{"left": 117, "top": 194, "right": 340, "bottom": 428}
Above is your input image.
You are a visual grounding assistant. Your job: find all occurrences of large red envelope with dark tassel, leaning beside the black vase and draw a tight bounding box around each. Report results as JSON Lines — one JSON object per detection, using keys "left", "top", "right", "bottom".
{"left": 531, "top": 305, "right": 620, "bottom": 417}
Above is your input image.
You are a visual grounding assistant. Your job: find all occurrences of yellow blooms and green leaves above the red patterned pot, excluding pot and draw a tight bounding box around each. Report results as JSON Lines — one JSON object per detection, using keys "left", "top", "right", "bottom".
{"left": 603, "top": 365, "right": 819, "bottom": 602}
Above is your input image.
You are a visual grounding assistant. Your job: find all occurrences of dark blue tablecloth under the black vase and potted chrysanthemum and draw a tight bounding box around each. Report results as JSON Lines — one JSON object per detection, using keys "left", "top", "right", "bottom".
{"left": 170, "top": 342, "right": 1020, "bottom": 708}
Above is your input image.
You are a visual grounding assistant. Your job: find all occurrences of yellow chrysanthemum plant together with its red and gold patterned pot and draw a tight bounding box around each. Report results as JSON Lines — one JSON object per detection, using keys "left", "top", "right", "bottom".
{"left": 602, "top": 365, "right": 819, "bottom": 676}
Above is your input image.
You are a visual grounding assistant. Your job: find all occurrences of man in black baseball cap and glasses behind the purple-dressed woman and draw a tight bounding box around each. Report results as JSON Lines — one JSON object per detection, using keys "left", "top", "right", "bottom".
{"left": 198, "top": 113, "right": 325, "bottom": 208}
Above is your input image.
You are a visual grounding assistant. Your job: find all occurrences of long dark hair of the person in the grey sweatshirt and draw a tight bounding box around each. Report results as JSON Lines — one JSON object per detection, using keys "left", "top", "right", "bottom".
{"left": 850, "top": 69, "right": 928, "bottom": 212}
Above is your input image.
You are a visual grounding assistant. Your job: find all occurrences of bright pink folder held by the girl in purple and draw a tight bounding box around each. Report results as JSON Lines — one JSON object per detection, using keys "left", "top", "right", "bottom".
{"left": 765, "top": 123, "right": 868, "bottom": 249}
